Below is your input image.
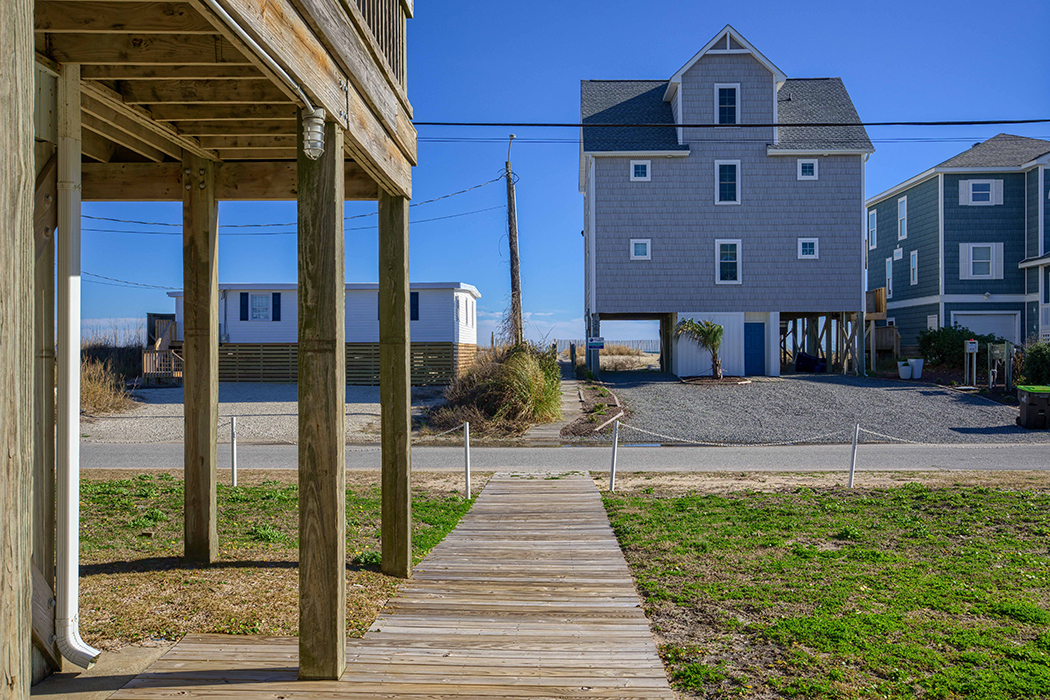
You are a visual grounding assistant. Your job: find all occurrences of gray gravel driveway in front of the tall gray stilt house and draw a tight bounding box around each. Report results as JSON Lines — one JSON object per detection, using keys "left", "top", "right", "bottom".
{"left": 602, "top": 372, "right": 1050, "bottom": 444}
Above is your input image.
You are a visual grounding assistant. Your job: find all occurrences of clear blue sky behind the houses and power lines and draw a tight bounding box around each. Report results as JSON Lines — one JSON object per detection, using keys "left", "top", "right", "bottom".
{"left": 83, "top": 0, "right": 1050, "bottom": 339}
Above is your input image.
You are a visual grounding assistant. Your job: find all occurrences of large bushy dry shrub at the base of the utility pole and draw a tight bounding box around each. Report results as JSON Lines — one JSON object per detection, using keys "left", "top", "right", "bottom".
{"left": 428, "top": 343, "right": 562, "bottom": 436}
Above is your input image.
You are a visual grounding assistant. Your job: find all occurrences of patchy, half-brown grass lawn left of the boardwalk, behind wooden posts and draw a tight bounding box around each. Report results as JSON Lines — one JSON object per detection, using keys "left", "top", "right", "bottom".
{"left": 81, "top": 470, "right": 488, "bottom": 649}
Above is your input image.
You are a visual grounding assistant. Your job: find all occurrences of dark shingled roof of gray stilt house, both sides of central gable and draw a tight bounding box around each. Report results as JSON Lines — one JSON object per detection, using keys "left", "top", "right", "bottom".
{"left": 580, "top": 78, "right": 875, "bottom": 151}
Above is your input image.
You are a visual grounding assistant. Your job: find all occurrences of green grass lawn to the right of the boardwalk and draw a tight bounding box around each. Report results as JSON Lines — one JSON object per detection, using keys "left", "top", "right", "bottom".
{"left": 605, "top": 476, "right": 1050, "bottom": 699}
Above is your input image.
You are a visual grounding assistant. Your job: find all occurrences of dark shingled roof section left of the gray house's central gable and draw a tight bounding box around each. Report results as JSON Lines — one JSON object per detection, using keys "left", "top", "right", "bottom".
{"left": 580, "top": 80, "right": 689, "bottom": 151}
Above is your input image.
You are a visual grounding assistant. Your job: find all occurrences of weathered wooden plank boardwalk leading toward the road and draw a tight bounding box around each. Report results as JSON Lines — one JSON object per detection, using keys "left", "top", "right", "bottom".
{"left": 112, "top": 474, "right": 674, "bottom": 700}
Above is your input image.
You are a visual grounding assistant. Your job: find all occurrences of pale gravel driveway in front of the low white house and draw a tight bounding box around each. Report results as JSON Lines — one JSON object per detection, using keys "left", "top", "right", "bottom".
{"left": 80, "top": 382, "right": 444, "bottom": 444}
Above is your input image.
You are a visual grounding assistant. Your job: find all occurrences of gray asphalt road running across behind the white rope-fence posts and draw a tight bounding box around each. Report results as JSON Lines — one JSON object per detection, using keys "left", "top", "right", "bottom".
{"left": 80, "top": 443, "right": 1050, "bottom": 471}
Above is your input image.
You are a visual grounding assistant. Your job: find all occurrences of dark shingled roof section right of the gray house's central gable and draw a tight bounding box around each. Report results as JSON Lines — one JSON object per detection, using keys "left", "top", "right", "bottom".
{"left": 770, "top": 78, "right": 875, "bottom": 151}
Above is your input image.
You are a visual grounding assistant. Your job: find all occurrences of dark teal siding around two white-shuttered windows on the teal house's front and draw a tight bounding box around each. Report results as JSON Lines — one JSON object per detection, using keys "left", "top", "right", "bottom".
{"left": 944, "top": 173, "right": 1025, "bottom": 294}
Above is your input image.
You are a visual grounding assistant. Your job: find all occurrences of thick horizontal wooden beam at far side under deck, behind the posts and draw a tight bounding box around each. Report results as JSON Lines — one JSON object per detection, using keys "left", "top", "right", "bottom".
{"left": 83, "top": 161, "right": 379, "bottom": 201}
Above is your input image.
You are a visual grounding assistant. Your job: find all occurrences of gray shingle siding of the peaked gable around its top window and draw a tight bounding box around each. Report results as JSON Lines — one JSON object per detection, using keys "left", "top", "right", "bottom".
{"left": 678, "top": 54, "right": 775, "bottom": 147}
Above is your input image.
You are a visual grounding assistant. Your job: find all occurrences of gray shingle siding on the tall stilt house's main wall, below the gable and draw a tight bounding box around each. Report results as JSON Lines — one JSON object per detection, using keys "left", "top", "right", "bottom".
{"left": 593, "top": 146, "right": 863, "bottom": 314}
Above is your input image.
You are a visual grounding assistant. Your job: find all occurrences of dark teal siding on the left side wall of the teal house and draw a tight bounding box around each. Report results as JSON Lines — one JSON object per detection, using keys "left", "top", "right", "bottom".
{"left": 867, "top": 176, "right": 941, "bottom": 300}
